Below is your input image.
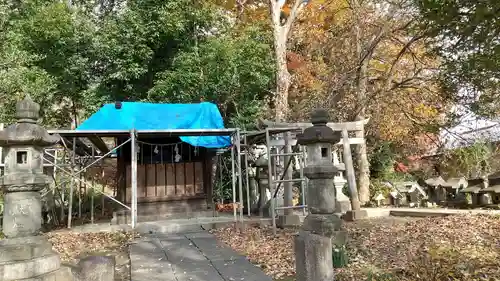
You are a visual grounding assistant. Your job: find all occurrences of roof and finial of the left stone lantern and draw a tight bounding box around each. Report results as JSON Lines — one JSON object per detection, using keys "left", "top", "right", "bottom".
{"left": 0, "top": 95, "right": 59, "bottom": 147}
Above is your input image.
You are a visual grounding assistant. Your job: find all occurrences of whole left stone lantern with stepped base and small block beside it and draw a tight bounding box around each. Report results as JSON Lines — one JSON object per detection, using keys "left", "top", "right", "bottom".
{"left": 0, "top": 96, "right": 114, "bottom": 281}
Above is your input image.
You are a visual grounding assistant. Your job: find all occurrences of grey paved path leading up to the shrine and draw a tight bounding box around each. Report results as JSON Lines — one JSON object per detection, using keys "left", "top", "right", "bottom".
{"left": 130, "top": 229, "right": 272, "bottom": 281}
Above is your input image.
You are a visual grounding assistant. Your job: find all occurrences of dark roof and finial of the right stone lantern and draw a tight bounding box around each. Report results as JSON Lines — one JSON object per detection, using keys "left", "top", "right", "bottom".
{"left": 297, "top": 109, "right": 341, "bottom": 145}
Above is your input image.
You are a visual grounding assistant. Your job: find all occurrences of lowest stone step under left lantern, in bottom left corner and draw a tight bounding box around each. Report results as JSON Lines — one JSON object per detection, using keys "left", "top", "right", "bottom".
{"left": 0, "top": 252, "right": 61, "bottom": 281}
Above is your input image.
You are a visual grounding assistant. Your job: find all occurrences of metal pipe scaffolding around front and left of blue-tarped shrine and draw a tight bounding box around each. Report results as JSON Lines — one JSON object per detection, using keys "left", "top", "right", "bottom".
{"left": 28, "top": 129, "right": 244, "bottom": 228}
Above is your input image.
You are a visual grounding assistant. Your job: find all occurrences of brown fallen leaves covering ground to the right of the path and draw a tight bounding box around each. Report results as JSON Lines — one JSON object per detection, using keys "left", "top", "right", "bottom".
{"left": 213, "top": 215, "right": 500, "bottom": 281}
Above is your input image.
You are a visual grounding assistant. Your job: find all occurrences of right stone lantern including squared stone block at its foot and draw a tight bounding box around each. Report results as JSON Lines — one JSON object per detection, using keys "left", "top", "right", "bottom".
{"left": 295, "top": 109, "right": 343, "bottom": 281}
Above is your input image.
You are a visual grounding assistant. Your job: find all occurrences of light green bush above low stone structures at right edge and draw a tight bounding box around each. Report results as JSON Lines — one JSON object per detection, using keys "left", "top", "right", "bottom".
{"left": 441, "top": 141, "right": 497, "bottom": 177}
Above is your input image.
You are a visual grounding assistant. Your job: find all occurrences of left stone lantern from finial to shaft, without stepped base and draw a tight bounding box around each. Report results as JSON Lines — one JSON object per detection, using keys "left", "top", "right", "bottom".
{"left": 0, "top": 96, "right": 59, "bottom": 238}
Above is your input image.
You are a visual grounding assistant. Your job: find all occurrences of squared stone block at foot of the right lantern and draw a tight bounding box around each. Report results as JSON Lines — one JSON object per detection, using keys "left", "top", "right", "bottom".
{"left": 294, "top": 231, "right": 333, "bottom": 281}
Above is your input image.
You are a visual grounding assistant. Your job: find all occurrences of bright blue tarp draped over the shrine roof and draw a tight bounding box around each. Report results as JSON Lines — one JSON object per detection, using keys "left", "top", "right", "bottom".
{"left": 76, "top": 102, "right": 231, "bottom": 148}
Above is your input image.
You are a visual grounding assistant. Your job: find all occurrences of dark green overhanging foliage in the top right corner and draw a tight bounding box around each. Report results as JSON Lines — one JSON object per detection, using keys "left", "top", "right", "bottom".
{"left": 415, "top": 0, "right": 500, "bottom": 115}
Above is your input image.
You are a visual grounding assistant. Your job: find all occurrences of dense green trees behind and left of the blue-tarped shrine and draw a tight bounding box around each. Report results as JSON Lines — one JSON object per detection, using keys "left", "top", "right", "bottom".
{"left": 0, "top": 0, "right": 274, "bottom": 127}
